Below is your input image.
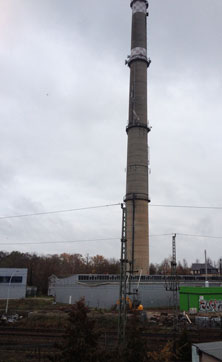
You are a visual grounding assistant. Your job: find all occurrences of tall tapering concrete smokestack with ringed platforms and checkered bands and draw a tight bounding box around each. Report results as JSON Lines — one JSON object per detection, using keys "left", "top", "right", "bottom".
{"left": 124, "top": 0, "right": 150, "bottom": 274}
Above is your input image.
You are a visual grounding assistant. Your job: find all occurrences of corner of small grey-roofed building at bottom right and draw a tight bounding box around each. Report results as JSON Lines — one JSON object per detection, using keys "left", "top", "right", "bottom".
{"left": 192, "top": 342, "right": 222, "bottom": 362}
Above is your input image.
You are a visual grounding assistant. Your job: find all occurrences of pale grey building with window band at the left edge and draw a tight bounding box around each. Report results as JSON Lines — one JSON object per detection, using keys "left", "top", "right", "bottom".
{"left": 0, "top": 268, "right": 28, "bottom": 299}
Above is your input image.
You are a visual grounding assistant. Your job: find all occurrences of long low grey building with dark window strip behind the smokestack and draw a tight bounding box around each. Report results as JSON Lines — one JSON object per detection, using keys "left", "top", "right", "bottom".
{"left": 48, "top": 274, "right": 222, "bottom": 308}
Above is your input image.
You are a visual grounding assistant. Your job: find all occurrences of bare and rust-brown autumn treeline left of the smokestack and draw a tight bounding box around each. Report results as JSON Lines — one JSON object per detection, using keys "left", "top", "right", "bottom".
{"left": 0, "top": 251, "right": 119, "bottom": 294}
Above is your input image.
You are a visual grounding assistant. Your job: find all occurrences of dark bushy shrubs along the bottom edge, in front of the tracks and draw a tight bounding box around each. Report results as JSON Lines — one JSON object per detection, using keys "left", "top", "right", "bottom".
{"left": 50, "top": 299, "right": 191, "bottom": 362}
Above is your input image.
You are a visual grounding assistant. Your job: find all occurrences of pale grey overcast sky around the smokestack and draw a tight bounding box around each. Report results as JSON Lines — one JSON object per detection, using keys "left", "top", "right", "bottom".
{"left": 0, "top": 0, "right": 222, "bottom": 263}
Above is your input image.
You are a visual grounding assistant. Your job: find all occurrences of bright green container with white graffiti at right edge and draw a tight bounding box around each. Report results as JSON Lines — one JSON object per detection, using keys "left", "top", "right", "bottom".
{"left": 179, "top": 287, "right": 222, "bottom": 312}
